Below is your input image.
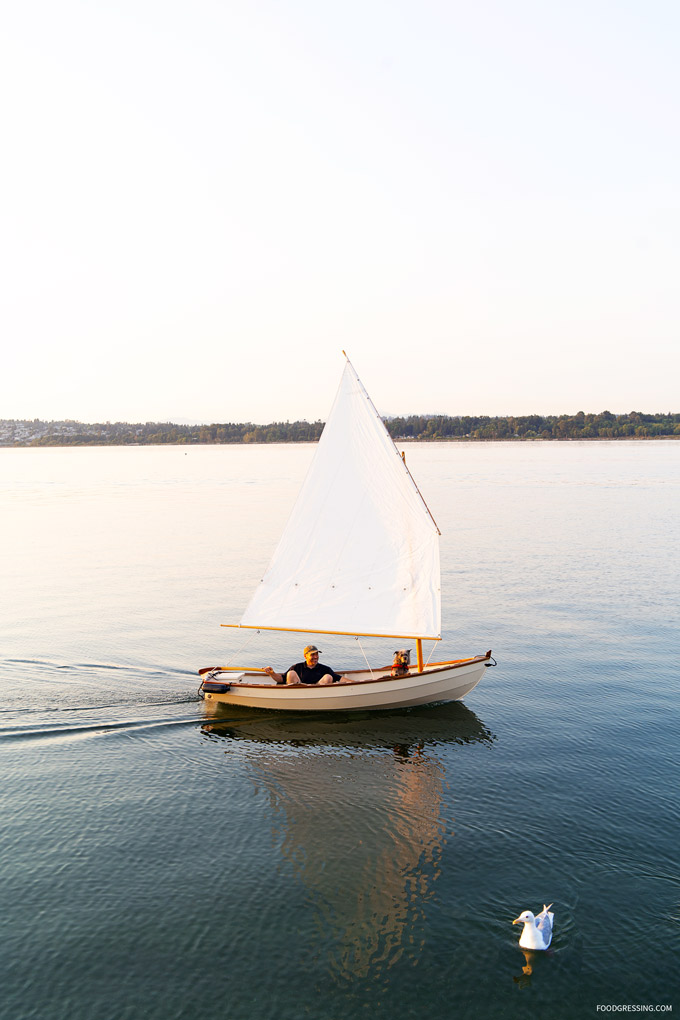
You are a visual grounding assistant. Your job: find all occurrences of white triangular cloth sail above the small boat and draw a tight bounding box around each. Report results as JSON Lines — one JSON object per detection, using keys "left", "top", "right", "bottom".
{"left": 241, "top": 361, "right": 441, "bottom": 639}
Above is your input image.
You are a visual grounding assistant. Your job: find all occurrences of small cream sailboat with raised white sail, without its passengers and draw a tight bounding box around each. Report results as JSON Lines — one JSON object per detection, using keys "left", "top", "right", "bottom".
{"left": 199, "top": 352, "right": 495, "bottom": 712}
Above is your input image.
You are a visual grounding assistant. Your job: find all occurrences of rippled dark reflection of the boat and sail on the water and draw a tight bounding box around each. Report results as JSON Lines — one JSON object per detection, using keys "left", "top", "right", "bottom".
{"left": 202, "top": 702, "right": 495, "bottom": 984}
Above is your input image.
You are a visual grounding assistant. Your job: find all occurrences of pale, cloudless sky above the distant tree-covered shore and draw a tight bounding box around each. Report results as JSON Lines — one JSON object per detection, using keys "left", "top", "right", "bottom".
{"left": 0, "top": 0, "right": 680, "bottom": 422}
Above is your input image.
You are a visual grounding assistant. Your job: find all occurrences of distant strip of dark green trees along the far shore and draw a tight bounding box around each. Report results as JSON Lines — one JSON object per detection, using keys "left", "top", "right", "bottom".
{"left": 0, "top": 411, "right": 680, "bottom": 447}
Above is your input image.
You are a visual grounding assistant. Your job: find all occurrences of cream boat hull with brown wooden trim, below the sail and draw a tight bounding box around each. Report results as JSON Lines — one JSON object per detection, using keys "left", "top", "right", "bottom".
{"left": 203, "top": 652, "right": 494, "bottom": 712}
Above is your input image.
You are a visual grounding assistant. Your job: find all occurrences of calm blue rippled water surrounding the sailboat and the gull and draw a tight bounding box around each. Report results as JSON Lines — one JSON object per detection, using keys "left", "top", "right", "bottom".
{"left": 0, "top": 442, "right": 680, "bottom": 1020}
